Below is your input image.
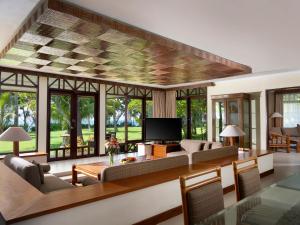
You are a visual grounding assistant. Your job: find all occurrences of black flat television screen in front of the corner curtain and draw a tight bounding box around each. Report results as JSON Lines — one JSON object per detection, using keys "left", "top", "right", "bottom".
{"left": 145, "top": 118, "right": 182, "bottom": 141}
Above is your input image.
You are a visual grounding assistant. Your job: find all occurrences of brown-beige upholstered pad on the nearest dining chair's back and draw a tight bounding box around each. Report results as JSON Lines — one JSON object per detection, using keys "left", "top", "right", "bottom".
{"left": 187, "top": 181, "right": 224, "bottom": 224}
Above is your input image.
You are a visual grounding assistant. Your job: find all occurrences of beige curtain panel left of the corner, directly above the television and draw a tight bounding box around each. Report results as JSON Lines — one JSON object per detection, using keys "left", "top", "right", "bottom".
{"left": 152, "top": 91, "right": 166, "bottom": 118}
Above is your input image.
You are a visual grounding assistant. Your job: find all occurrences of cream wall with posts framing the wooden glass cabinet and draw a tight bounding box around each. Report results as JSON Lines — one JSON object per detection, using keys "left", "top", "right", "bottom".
{"left": 207, "top": 71, "right": 300, "bottom": 149}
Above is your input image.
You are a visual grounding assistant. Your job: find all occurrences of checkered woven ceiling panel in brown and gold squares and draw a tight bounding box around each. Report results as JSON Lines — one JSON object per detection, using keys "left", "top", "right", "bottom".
{"left": 0, "top": 0, "right": 251, "bottom": 85}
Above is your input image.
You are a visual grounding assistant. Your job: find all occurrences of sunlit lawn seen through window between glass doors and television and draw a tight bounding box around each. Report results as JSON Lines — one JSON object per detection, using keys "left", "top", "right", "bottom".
{"left": 106, "top": 127, "right": 142, "bottom": 142}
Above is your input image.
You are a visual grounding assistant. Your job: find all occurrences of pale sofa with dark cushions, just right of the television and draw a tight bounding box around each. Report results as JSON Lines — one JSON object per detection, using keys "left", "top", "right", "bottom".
{"left": 167, "top": 139, "right": 223, "bottom": 164}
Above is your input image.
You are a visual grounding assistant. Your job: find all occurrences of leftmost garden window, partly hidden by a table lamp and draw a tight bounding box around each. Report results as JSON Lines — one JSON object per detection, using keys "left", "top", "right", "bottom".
{"left": 0, "top": 91, "right": 37, "bottom": 154}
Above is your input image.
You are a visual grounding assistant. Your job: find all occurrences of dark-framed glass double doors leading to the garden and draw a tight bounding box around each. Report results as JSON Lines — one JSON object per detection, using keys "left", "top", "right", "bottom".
{"left": 47, "top": 90, "right": 99, "bottom": 161}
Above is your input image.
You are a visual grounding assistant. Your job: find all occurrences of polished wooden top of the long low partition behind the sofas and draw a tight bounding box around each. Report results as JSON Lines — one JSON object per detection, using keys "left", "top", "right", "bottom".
{"left": 0, "top": 151, "right": 271, "bottom": 224}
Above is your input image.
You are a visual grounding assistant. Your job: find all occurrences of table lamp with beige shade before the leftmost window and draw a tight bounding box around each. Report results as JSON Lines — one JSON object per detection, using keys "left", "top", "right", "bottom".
{"left": 0, "top": 127, "right": 31, "bottom": 156}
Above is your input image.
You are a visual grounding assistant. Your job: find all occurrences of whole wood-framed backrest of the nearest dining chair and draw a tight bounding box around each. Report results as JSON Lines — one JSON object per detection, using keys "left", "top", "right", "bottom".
{"left": 179, "top": 168, "right": 224, "bottom": 225}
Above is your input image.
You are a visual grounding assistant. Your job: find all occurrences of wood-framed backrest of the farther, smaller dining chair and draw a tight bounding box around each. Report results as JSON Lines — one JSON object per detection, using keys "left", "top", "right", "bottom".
{"left": 232, "top": 157, "right": 261, "bottom": 201}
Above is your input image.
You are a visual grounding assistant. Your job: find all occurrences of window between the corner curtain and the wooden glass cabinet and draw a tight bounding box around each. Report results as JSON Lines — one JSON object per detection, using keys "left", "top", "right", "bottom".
{"left": 176, "top": 97, "right": 207, "bottom": 140}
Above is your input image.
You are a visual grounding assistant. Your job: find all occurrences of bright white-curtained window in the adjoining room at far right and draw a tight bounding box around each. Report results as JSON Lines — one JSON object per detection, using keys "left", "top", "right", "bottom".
{"left": 283, "top": 93, "right": 300, "bottom": 127}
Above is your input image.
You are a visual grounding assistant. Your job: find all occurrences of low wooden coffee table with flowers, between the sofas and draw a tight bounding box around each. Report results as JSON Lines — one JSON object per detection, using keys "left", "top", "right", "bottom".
{"left": 72, "top": 156, "right": 157, "bottom": 185}
